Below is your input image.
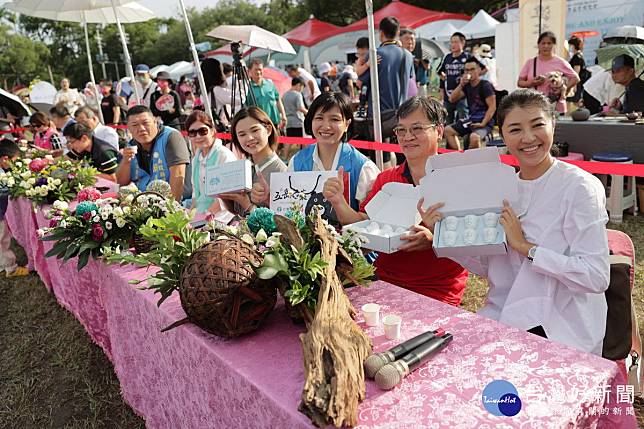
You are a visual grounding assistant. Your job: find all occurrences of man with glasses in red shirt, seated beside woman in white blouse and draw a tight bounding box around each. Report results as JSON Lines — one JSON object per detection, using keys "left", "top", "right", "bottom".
{"left": 323, "top": 96, "right": 467, "bottom": 305}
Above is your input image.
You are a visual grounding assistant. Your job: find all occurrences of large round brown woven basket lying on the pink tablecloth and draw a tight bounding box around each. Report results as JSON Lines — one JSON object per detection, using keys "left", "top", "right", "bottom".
{"left": 179, "top": 238, "right": 277, "bottom": 338}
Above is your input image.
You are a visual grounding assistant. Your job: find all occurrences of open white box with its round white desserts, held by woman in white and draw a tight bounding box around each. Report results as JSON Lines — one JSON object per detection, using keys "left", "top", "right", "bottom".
{"left": 420, "top": 148, "right": 518, "bottom": 257}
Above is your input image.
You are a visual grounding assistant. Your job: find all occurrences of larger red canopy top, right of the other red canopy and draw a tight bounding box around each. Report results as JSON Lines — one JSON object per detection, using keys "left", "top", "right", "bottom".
{"left": 336, "top": 0, "right": 472, "bottom": 34}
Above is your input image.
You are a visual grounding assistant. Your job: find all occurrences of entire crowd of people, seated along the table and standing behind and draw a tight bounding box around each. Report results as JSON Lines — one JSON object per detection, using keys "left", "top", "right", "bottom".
{"left": 0, "top": 13, "right": 644, "bottom": 354}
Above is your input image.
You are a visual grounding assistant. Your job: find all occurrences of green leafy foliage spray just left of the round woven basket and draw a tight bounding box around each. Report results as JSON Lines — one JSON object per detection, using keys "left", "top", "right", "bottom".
{"left": 106, "top": 210, "right": 210, "bottom": 305}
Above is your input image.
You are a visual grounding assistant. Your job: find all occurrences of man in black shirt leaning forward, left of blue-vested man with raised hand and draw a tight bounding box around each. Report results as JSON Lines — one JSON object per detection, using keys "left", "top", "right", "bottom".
{"left": 63, "top": 123, "right": 119, "bottom": 182}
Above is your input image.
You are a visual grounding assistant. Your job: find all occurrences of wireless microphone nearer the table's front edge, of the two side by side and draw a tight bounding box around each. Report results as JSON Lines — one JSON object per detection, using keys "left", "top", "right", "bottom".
{"left": 376, "top": 334, "right": 452, "bottom": 390}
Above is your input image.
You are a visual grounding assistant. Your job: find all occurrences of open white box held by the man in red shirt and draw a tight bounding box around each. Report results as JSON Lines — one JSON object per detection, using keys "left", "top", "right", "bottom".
{"left": 342, "top": 182, "right": 420, "bottom": 253}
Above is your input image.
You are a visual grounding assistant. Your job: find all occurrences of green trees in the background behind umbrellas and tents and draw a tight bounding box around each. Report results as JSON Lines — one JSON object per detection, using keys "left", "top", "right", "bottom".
{"left": 0, "top": 0, "right": 506, "bottom": 89}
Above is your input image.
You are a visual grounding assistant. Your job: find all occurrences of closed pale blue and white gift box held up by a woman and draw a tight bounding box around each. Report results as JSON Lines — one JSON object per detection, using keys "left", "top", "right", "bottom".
{"left": 206, "top": 159, "right": 253, "bottom": 196}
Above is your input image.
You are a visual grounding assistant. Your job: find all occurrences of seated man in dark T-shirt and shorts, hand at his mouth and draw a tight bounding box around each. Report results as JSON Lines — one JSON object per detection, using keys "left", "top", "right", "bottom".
{"left": 445, "top": 57, "right": 496, "bottom": 150}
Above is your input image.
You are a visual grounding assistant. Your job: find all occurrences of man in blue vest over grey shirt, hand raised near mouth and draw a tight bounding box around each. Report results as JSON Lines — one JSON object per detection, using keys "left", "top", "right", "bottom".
{"left": 116, "top": 105, "right": 190, "bottom": 202}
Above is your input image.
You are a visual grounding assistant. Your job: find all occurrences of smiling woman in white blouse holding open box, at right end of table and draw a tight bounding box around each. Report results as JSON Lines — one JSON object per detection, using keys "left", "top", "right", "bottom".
{"left": 419, "top": 89, "right": 610, "bottom": 355}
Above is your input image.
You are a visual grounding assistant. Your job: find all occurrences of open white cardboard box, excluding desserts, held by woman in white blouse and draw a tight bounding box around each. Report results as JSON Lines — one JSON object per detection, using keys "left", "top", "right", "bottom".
{"left": 420, "top": 147, "right": 519, "bottom": 257}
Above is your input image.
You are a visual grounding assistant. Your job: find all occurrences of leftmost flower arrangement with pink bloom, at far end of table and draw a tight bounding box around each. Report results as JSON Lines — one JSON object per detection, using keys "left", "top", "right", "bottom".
{"left": 0, "top": 155, "right": 97, "bottom": 204}
